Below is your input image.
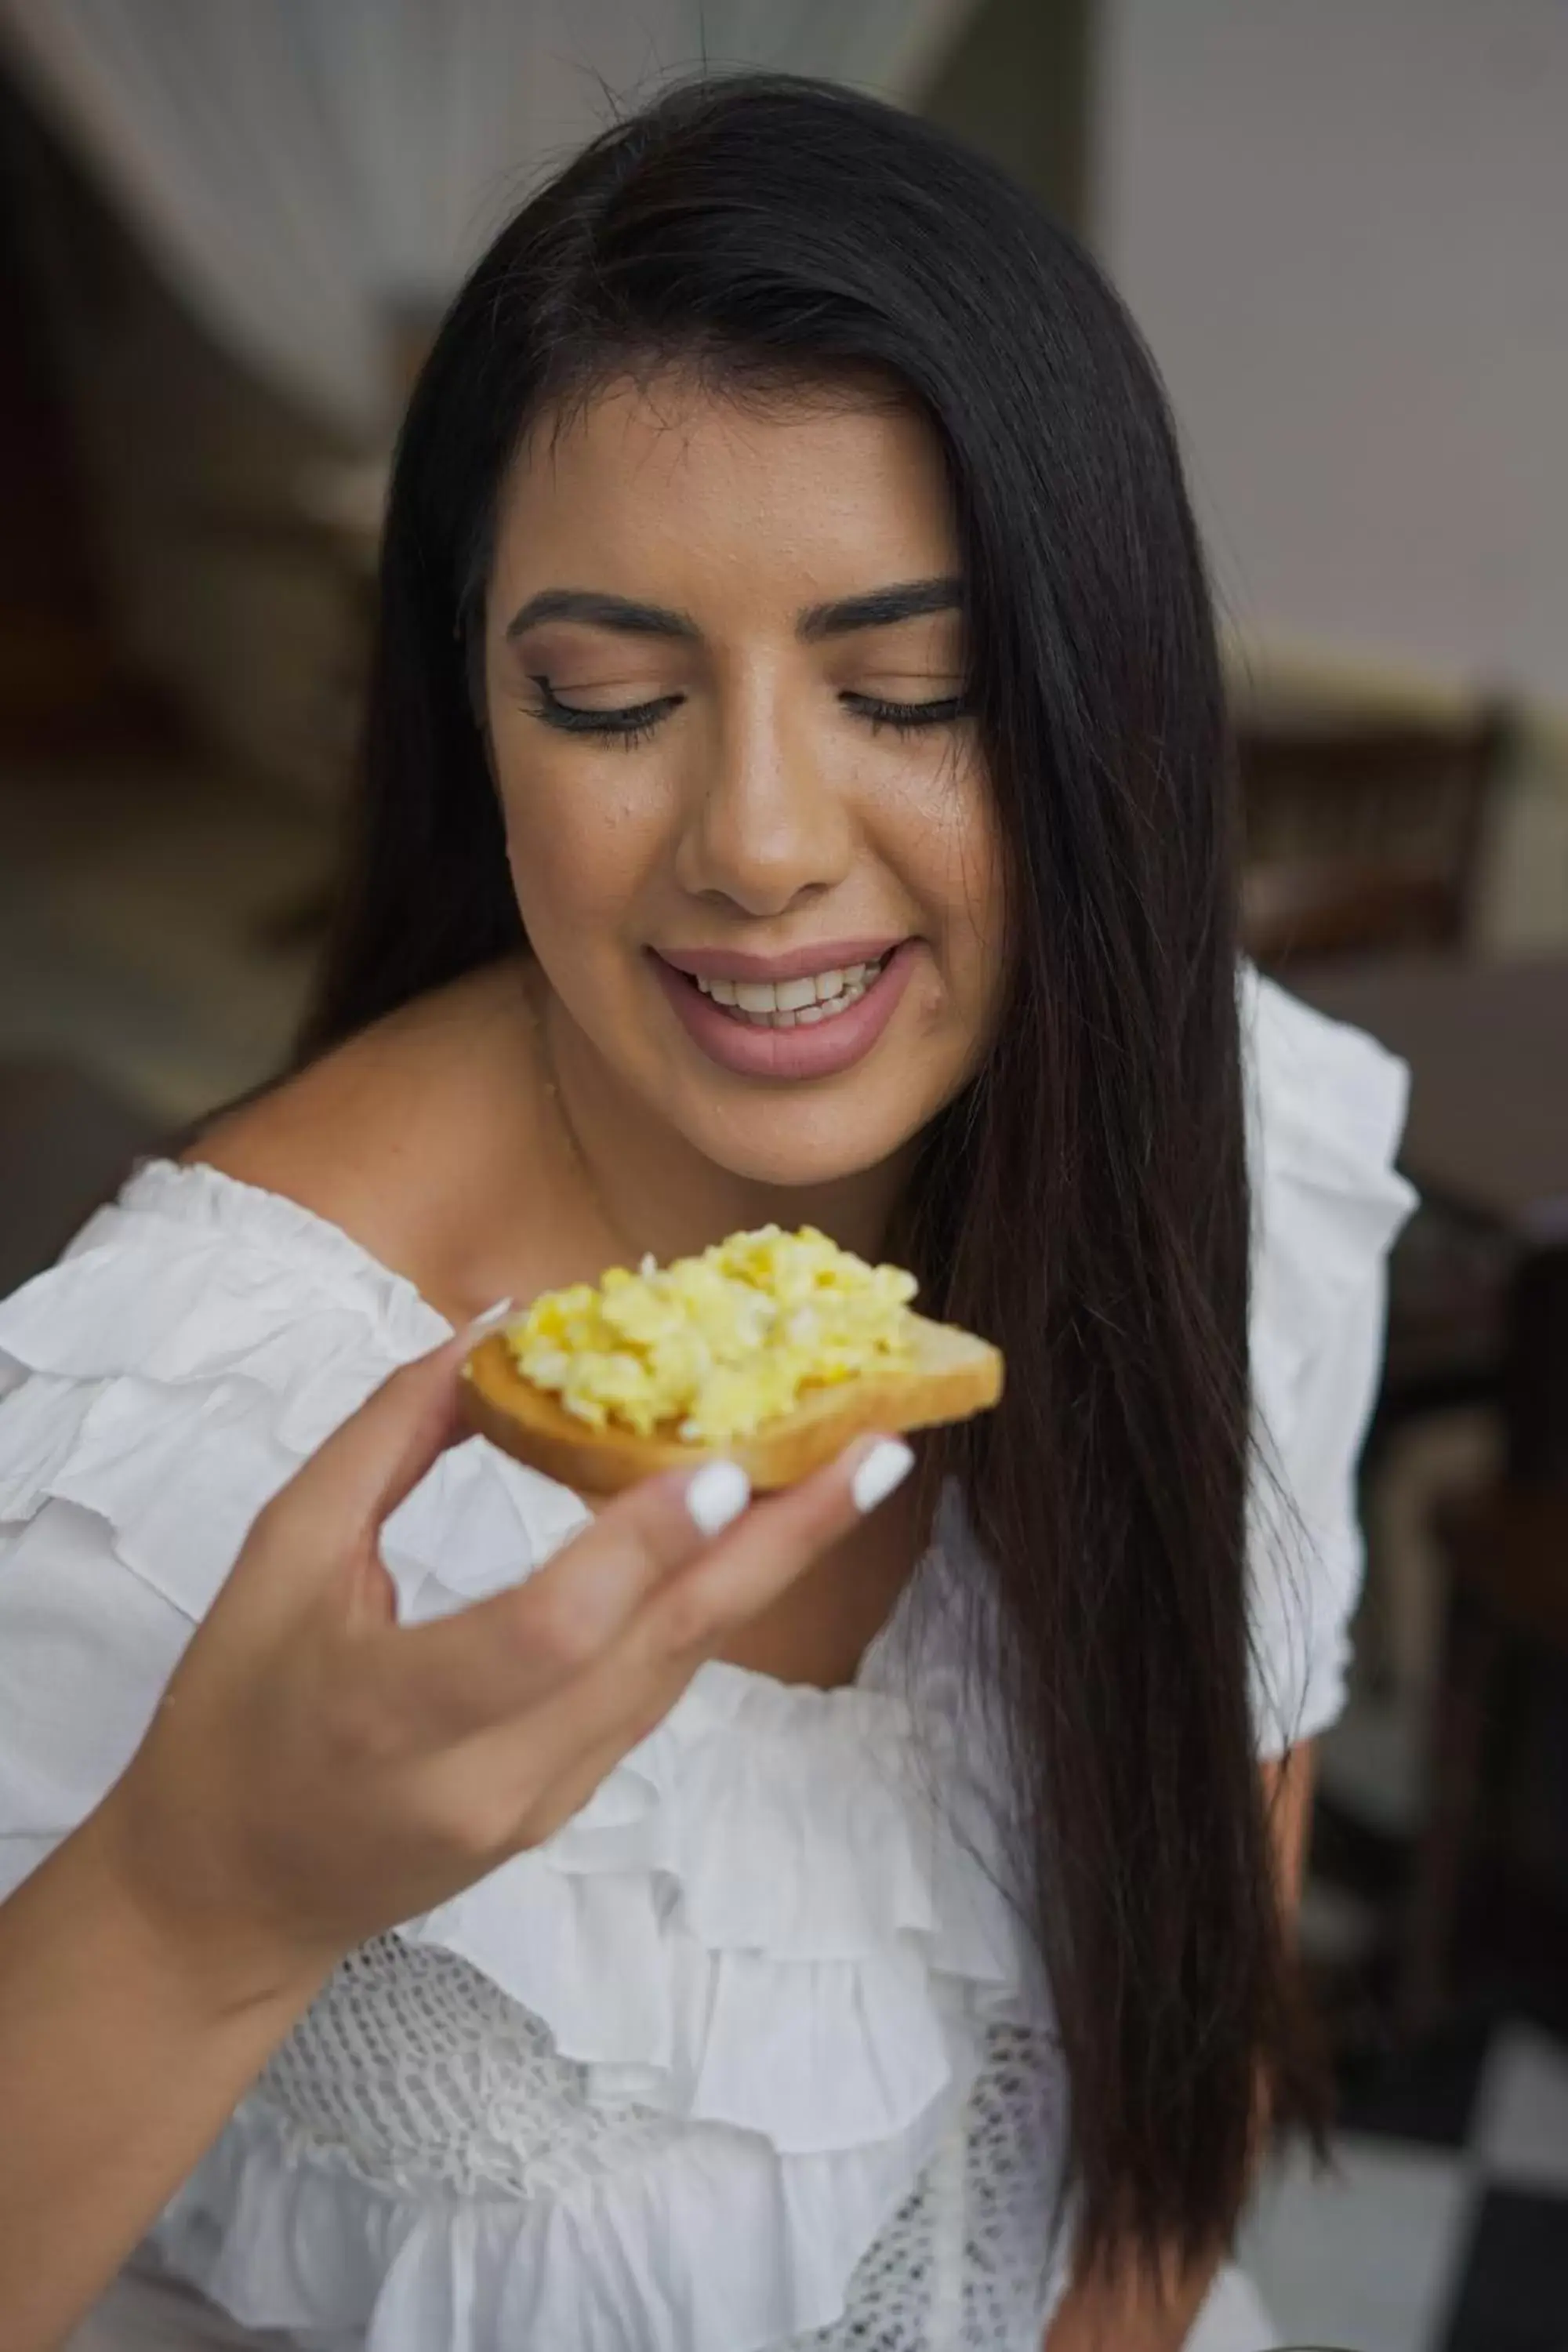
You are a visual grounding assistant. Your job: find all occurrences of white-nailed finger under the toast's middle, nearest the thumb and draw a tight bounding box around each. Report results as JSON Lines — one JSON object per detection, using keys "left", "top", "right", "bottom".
{"left": 381, "top": 1458, "right": 750, "bottom": 1740}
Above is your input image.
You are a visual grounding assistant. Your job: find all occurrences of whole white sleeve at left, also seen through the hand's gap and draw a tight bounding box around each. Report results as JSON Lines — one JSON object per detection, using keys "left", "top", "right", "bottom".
{"left": 0, "top": 1162, "right": 571, "bottom": 1900}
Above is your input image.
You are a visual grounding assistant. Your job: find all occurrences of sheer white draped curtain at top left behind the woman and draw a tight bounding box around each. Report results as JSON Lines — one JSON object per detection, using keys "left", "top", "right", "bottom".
{"left": 0, "top": 0, "right": 973, "bottom": 440}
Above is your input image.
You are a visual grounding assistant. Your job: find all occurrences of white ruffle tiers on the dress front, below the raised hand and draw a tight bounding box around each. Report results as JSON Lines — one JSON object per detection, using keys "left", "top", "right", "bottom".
{"left": 140, "top": 1663, "right": 1022, "bottom": 2352}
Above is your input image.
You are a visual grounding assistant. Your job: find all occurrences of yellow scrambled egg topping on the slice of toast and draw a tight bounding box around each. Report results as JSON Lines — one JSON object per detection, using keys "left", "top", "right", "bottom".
{"left": 506, "top": 1225, "right": 916, "bottom": 1444}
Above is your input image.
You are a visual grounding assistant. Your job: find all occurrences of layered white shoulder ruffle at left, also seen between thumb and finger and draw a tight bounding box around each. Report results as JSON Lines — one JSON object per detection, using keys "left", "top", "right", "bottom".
{"left": 0, "top": 1160, "right": 588, "bottom": 1625}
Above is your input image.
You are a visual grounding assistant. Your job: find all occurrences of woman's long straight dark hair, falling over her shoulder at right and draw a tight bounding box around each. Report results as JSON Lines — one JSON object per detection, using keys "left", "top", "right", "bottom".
{"left": 301, "top": 78, "right": 1309, "bottom": 2260}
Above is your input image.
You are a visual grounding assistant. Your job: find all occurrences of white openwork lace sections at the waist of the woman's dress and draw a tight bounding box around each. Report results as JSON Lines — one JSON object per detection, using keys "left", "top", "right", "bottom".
{"left": 254, "top": 1936, "right": 1065, "bottom": 2352}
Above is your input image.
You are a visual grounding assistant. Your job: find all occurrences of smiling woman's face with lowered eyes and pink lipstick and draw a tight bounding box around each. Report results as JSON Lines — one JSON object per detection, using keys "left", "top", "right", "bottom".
{"left": 485, "top": 376, "right": 1001, "bottom": 1185}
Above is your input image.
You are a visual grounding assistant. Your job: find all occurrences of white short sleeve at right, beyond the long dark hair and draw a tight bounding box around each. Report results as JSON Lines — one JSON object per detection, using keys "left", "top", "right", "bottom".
{"left": 1241, "top": 967, "right": 1415, "bottom": 1757}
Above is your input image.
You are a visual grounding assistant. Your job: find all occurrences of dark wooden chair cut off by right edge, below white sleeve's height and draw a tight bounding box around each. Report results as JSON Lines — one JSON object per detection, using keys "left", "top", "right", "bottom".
{"left": 1399, "top": 1242, "right": 1568, "bottom": 2034}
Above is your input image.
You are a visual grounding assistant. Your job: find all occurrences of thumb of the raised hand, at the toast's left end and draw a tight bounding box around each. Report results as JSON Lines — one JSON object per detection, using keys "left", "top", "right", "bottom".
{"left": 273, "top": 1298, "right": 513, "bottom": 1552}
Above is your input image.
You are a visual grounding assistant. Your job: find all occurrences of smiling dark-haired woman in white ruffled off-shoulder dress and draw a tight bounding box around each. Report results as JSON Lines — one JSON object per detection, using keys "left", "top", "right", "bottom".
{"left": 0, "top": 80, "right": 1408, "bottom": 2352}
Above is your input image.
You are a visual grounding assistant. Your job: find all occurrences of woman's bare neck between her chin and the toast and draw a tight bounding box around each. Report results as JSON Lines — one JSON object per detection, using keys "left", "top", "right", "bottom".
{"left": 534, "top": 985, "right": 914, "bottom": 1263}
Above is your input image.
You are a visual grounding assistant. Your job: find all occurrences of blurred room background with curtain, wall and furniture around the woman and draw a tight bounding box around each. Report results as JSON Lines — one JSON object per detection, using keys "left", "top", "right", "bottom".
{"left": 0, "top": 0, "right": 1568, "bottom": 2352}
